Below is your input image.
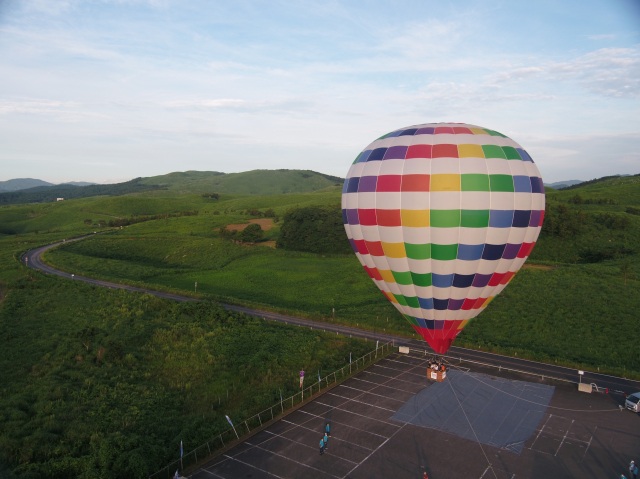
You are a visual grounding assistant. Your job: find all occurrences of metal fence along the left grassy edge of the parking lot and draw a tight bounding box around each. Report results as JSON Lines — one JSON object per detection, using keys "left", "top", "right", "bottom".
{"left": 149, "top": 342, "right": 395, "bottom": 479}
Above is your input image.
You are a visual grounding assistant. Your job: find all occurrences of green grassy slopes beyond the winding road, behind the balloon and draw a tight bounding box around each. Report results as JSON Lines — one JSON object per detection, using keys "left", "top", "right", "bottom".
{"left": 33, "top": 177, "right": 640, "bottom": 375}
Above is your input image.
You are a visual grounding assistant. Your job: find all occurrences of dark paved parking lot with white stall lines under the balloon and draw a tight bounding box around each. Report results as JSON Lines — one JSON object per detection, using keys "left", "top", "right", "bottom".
{"left": 189, "top": 354, "right": 640, "bottom": 479}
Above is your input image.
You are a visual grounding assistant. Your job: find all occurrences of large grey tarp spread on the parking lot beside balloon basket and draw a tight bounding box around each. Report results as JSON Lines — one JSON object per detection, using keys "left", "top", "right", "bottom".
{"left": 392, "top": 370, "right": 555, "bottom": 454}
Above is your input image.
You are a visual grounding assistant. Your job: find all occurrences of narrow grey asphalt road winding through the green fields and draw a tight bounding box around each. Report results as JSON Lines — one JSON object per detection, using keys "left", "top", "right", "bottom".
{"left": 22, "top": 235, "right": 640, "bottom": 394}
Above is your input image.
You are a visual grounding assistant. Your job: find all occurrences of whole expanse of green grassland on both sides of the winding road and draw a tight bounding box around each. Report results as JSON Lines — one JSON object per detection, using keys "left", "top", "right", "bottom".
{"left": 0, "top": 171, "right": 640, "bottom": 478}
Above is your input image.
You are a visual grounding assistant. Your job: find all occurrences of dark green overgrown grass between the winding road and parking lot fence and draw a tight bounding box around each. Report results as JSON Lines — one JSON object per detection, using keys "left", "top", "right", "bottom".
{"left": 0, "top": 273, "right": 371, "bottom": 478}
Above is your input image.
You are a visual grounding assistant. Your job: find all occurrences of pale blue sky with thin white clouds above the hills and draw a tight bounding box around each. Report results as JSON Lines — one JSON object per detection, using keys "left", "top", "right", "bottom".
{"left": 0, "top": 0, "right": 640, "bottom": 183}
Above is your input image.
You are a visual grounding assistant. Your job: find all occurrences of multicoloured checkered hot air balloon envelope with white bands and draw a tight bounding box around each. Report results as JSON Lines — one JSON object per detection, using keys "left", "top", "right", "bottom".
{"left": 342, "top": 123, "right": 545, "bottom": 354}
